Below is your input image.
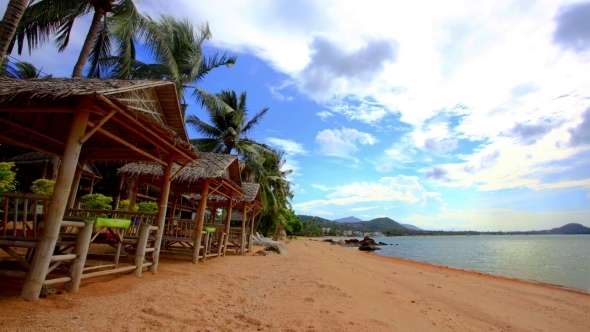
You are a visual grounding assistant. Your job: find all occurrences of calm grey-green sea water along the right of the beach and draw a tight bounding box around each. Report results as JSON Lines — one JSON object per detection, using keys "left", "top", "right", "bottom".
{"left": 368, "top": 235, "right": 590, "bottom": 292}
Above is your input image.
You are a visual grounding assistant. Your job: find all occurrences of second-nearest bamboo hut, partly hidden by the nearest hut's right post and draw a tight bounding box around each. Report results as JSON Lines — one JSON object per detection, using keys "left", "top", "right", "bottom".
{"left": 119, "top": 153, "right": 244, "bottom": 263}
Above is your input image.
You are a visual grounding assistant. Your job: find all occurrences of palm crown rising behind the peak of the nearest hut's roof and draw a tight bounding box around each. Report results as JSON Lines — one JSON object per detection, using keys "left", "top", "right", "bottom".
{"left": 103, "top": 15, "right": 237, "bottom": 105}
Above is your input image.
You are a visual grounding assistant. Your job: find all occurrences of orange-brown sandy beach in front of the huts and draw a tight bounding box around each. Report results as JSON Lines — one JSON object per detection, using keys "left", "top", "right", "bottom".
{"left": 0, "top": 239, "right": 590, "bottom": 331}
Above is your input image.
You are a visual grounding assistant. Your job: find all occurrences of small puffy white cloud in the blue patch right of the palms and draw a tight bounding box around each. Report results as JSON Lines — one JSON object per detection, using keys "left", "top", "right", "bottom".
{"left": 315, "top": 128, "right": 378, "bottom": 157}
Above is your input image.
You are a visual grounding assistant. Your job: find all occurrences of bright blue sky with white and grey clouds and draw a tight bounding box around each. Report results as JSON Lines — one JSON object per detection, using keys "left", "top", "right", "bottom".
{"left": 0, "top": 0, "right": 590, "bottom": 231}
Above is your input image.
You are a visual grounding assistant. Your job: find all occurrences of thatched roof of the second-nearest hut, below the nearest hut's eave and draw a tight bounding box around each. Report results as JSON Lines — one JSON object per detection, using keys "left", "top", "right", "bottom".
{"left": 117, "top": 153, "right": 242, "bottom": 197}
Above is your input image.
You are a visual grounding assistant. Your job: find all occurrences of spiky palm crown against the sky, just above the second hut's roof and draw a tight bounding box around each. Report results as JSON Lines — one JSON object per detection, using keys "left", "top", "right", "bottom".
{"left": 186, "top": 88, "right": 268, "bottom": 158}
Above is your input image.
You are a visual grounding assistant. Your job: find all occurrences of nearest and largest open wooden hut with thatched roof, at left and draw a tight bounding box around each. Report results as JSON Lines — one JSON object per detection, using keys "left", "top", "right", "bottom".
{"left": 0, "top": 78, "right": 198, "bottom": 301}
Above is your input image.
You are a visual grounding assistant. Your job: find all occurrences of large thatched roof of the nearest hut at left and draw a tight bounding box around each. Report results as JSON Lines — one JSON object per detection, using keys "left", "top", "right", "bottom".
{"left": 0, "top": 78, "right": 196, "bottom": 163}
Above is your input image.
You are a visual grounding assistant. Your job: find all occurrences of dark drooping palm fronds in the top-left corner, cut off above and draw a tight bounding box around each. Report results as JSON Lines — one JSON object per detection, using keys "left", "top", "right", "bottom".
{"left": 8, "top": 0, "right": 145, "bottom": 77}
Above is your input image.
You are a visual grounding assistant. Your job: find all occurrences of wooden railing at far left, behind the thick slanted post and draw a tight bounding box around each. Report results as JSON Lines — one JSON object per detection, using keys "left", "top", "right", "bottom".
{"left": 0, "top": 193, "right": 51, "bottom": 237}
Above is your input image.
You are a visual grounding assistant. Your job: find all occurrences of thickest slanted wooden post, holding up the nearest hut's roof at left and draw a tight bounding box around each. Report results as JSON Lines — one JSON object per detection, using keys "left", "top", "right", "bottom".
{"left": 21, "top": 105, "right": 91, "bottom": 302}
